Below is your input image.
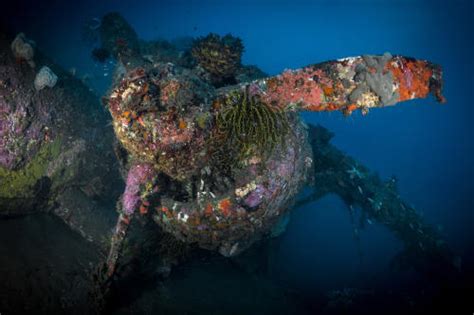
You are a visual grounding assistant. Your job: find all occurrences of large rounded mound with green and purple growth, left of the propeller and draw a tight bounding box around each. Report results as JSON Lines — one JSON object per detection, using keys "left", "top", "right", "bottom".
{"left": 0, "top": 32, "right": 121, "bottom": 245}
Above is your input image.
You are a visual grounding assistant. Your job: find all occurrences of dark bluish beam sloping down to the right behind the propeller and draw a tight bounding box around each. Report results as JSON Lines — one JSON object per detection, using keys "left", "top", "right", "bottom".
{"left": 296, "top": 125, "right": 457, "bottom": 278}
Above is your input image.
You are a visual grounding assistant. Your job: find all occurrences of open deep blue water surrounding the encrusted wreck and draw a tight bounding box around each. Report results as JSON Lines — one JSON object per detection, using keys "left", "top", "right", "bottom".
{"left": 2, "top": 0, "right": 474, "bottom": 312}
